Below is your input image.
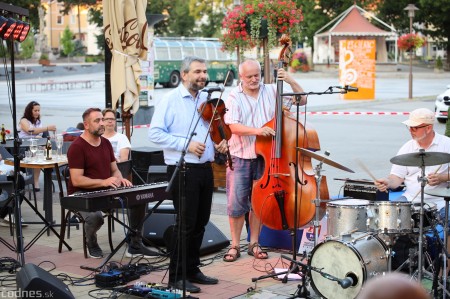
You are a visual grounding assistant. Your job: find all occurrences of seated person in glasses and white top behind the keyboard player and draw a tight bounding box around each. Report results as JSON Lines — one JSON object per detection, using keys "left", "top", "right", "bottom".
{"left": 102, "top": 108, "right": 131, "bottom": 162}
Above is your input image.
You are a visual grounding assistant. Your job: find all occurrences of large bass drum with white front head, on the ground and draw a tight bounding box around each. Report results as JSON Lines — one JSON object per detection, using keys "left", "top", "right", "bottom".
{"left": 309, "top": 233, "right": 388, "bottom": 299}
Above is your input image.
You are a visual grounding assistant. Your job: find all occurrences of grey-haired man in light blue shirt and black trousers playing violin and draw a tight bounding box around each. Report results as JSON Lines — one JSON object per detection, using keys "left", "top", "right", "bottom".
{"left": 148, "top": 56, "right": 227, "bottom": 293}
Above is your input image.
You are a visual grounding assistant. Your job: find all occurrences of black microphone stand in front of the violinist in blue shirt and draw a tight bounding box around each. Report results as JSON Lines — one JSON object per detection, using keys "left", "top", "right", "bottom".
{"left": 166, "top": 92, "right": 211, "bottom": 298}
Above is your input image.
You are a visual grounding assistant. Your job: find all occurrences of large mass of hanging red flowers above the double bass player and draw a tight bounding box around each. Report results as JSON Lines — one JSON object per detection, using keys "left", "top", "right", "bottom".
{"left": 221, "top": 0, "right": 303, "bottom": 51}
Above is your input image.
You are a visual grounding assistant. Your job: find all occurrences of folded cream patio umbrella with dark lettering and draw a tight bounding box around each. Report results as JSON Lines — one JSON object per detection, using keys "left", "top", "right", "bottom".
{"left": 103, "top": 0, "right": 148, "bottom": 138}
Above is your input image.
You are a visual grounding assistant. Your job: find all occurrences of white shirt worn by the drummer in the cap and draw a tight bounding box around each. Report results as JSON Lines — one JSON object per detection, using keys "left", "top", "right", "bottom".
{"left": 391, "top": 133, "right": 450, "bottom": 210}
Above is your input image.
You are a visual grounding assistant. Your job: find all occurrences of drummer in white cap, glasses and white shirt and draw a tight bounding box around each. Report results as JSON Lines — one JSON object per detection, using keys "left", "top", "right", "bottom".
{"left": 375, "top": 108, "right": 450, "bottom": 223}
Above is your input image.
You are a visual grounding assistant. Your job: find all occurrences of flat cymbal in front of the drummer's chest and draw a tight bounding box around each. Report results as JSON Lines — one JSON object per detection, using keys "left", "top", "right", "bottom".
{"left": 391, "top": 152, "right": 450, "bottom": 167}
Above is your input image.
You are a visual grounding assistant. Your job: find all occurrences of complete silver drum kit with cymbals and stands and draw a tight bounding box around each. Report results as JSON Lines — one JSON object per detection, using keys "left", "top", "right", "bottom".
{"left": 299, "top": 149, "right": 450, "bottom": 299}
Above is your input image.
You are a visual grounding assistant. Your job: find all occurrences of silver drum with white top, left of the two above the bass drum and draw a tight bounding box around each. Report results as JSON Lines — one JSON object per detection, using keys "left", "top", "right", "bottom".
{"left": 327, "top": 198, "right": 370, "bottom": 236}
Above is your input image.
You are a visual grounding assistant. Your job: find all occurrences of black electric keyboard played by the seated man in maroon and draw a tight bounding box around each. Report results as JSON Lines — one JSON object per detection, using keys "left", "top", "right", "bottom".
{"left": 61, "top": 182, "right": 170, "bottom": 212}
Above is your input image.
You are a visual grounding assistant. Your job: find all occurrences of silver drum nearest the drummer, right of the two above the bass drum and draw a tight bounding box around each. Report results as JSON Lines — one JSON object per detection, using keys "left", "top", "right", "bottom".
{"left": 367, "top": 201, "right": 412, "bottom": 234}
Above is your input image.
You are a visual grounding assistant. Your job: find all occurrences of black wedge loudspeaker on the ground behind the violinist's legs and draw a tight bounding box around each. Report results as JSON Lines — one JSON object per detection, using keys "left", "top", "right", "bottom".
{"left": 142, "top": 205, "right": 230, "bottom": 255}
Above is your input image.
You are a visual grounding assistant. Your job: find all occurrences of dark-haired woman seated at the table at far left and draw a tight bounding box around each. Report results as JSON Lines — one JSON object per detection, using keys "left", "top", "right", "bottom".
{"left": 17, "top": 101, "right": 56, "bottom": 191}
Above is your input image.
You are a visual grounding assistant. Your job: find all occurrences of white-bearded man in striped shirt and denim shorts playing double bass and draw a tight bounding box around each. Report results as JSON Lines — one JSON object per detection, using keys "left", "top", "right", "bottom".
{"left": 223, "top": 59, "right": 306, "bottom": 262}
